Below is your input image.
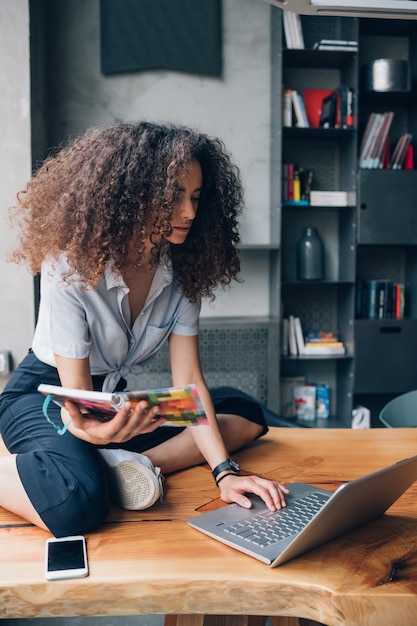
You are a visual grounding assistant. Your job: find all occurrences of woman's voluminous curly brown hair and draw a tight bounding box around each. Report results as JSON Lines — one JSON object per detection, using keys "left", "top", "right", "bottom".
{"left": 10, "top": 122, "right": 243, "bottom": 301}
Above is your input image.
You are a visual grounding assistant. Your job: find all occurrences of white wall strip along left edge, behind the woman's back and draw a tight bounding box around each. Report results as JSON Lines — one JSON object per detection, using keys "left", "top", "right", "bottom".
{"left": 0, "top": 0, "right": 34, "bottom": 388}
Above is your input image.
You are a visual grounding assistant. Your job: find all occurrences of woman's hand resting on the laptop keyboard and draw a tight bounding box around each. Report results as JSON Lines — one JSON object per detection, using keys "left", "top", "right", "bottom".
{"left": 219, "top": 474, "right": 289, "bottom": 511}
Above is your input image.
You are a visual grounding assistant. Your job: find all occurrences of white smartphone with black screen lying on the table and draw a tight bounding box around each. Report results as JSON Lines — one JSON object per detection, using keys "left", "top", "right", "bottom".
{"left": 45, "top": 535, "right": 88, "bottom": 580}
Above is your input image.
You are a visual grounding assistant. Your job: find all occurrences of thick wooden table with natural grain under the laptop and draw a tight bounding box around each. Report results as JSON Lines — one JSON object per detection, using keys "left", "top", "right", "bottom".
{"left": 0, "top": 428, "right": 417, "bottom": 626}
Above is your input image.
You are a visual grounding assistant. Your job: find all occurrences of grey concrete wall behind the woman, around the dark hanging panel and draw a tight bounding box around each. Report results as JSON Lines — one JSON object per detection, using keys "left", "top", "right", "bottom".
{"left": 44, "top": 0, "right": 271, "bottom": 317}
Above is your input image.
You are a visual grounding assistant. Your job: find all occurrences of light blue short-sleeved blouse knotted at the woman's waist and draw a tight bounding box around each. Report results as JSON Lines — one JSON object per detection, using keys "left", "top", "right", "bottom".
{"left": 32, "top": 256, "right": 201, "bottom": 391}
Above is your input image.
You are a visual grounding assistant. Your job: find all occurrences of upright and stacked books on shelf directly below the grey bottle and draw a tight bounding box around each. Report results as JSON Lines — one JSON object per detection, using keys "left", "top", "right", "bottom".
{"left": 282, "top": 315, "right": 346, "bottom": 356}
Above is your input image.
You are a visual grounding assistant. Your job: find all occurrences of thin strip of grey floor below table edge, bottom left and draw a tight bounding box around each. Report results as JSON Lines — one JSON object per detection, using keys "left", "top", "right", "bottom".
{"left": 0, "top": 615, "right": 164, "bottom": 626}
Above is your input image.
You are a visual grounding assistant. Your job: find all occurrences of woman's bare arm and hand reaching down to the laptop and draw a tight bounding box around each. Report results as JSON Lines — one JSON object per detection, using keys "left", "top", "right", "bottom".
{"left": 169, "top": 334, "right": 288, "bottom": 510}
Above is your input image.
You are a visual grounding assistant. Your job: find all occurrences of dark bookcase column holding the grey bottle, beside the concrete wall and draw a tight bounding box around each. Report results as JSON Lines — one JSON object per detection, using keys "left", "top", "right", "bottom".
{"left": 273, "top": 12, "right": 358, "bottom": 427}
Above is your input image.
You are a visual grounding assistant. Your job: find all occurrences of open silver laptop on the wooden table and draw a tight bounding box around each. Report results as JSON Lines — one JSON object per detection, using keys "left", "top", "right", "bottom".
{"left": 188, "top": 456, "right": 417, "bottom": 567}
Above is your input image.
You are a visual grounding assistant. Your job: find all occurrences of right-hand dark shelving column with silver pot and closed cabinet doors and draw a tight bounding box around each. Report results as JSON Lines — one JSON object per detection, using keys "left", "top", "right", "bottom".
{"left": 354, "top": 20, "right": 417, "bottom": 426}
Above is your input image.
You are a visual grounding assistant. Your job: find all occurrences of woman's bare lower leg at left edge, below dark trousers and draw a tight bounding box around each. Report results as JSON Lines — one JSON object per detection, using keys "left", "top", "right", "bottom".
{"left": 0, "top": 455, "right": 48, "bottom": 530}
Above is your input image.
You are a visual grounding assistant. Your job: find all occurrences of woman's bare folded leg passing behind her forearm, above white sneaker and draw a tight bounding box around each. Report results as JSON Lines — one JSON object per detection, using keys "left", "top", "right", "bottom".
{"left": 144, "top": 414, "right": 262, "bottom": 475}
